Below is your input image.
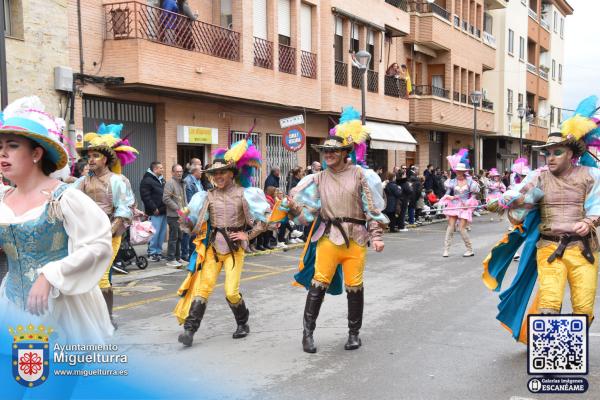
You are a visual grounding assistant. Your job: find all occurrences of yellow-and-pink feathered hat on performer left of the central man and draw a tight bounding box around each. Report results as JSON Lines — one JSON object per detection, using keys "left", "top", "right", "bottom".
{"left": 203, "top": 127, "right": 262, "bottom": 188}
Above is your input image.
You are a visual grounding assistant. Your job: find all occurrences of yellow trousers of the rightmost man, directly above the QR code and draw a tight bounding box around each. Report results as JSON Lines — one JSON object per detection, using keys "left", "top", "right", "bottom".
{"left": 537, "top": 244, "right": 598, "bottom": 322}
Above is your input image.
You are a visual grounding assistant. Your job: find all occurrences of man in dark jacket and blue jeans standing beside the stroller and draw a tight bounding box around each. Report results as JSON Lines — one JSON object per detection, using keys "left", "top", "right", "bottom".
{"left": 140, "top": 161, "right": 167, "bottom": 261}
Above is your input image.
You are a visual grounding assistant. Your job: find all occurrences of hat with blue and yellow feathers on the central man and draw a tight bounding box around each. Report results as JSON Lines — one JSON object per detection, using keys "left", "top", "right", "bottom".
{"left": 312, "top": 106, "right": 369, "bottom": 165}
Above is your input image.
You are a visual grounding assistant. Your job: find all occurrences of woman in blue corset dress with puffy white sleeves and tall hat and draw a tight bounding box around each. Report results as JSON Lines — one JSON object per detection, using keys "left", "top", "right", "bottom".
{"left": 0, "top": 97, "right": 113, "bottom": 343}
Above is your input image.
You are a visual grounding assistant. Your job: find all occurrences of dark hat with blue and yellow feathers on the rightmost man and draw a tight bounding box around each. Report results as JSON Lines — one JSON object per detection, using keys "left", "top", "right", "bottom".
{"left": 533, "top": 96, "right": 600, "bottom": 158}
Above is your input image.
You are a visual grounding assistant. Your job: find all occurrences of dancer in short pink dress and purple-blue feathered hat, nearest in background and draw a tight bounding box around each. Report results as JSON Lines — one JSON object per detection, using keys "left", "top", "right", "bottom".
{"left": 440, "top": 149, "right": 479, "bottom": 257}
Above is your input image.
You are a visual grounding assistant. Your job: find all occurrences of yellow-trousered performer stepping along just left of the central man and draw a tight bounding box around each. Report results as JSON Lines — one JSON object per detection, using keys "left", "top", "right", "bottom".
{"left": 174, "top": 134, "right": 270, "bottom": 346}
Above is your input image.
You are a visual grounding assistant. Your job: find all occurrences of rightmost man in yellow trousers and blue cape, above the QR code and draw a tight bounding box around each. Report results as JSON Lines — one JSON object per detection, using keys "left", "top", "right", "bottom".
{"left": 483, "top": 96, "right": 600, "bottom": 343}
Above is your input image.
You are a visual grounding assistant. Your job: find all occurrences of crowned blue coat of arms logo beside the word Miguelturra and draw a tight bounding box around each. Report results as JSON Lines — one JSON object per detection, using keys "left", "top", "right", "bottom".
{"left": 8, "top": 324, "right": 52, "bottom": 387}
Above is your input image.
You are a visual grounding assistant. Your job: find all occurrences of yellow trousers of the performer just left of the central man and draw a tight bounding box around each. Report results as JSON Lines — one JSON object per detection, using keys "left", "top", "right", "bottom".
{"left": 194, "top": 246, "right": 245, "bottom": 304}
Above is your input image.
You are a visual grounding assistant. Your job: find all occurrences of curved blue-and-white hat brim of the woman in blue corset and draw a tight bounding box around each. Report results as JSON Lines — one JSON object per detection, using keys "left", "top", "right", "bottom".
{"left": 0, "top": 117, "right": 69, "bottom": 170}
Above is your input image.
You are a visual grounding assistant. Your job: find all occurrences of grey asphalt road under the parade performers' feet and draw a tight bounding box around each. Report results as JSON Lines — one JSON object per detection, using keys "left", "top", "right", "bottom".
{"left": 109, "top": 216, "right": 600, "bottom": 400}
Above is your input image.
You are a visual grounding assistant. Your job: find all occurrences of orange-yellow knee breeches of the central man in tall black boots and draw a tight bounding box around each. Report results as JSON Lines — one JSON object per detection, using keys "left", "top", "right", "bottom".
{"left": 313, "top": 237, "right": 367, "bottom": 286}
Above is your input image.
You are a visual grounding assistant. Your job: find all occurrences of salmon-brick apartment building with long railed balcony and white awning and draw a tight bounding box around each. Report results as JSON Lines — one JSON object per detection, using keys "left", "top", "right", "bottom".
{"left": 64, "top": 0, "right": 415, "bottom": 195}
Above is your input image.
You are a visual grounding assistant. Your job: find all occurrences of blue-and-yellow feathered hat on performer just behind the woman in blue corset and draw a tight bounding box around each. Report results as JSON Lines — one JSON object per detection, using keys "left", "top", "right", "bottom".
{"left": 83, "top": 123, "right": 138, "bottom": 174}
